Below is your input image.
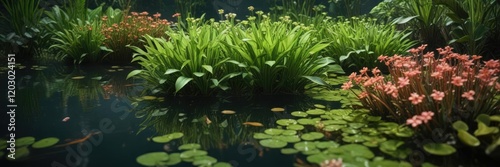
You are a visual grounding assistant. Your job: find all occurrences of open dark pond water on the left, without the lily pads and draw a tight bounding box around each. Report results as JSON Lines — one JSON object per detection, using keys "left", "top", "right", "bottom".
{"left": 0, "top": 65, "right": 326, "bottom": 167}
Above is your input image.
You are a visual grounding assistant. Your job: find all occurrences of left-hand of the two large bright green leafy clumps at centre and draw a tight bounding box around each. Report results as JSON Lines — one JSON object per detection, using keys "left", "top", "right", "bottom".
{"left": 129, "top": 18, "right": 233, "bottom": 96}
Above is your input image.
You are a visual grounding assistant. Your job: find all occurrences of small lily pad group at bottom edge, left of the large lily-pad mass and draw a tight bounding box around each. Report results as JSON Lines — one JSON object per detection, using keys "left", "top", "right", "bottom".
{"left": 136, "top": 132, "right": 231, "bottom": 167}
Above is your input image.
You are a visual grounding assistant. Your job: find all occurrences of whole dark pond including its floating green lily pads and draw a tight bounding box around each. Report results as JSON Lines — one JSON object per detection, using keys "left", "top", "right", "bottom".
{"left": 0, "top": 65, "right": 495, "bottom": 167}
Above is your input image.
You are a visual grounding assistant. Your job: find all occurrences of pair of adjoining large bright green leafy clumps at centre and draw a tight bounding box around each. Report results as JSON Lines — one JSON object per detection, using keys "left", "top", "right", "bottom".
{"left": 129, "top": 15, "right": 333, "bottom": 95}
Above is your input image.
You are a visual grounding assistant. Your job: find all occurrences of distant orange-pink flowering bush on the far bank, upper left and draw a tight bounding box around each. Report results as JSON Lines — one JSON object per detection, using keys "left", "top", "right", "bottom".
{"left": 101, "top": 9, "right": 170, "bottom": 63}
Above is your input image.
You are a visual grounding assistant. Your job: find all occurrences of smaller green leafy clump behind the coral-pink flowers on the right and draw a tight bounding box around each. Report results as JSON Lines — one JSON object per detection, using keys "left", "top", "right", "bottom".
{"left": 318, "top": 17, "right": 416, "bottom": 71}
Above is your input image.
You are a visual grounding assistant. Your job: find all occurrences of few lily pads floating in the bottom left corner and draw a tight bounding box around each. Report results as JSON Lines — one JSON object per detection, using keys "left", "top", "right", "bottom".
{"left": 0, "top": 136, "right": 59, "bottom": 160}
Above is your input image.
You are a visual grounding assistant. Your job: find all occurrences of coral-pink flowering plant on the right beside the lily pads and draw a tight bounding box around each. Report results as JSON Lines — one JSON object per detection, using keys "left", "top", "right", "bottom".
{"left": 342, "top": 45, "right": 500, "bottom": 131}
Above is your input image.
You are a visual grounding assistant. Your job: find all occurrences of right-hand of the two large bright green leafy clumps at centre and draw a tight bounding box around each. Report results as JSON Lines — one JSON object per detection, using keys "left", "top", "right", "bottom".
{"left": 225, "top": 12, "right": 334, "bottom": 94}
